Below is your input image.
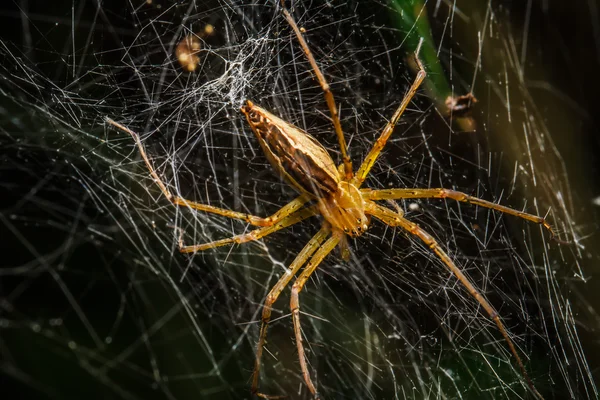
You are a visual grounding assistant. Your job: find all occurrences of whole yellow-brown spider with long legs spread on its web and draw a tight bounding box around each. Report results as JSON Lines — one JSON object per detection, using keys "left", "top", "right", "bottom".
{"left": 107, "top": 4, "right": 553, "bottom": 399}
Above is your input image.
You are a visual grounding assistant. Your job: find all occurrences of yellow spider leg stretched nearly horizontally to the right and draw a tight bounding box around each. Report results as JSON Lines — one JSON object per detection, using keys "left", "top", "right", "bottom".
{"left": 361, "top": 188, "right": 554, "bottom": 237}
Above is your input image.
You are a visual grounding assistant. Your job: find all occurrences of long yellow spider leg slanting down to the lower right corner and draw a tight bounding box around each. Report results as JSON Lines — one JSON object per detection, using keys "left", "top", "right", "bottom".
{"left": 367, "top": 202, "right": 544, "bottom": 400}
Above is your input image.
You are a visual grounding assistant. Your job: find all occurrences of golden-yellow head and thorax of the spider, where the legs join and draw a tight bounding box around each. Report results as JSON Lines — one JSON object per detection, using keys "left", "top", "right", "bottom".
{"left": 319, "top": 182, "right": 371, "bottom": 237}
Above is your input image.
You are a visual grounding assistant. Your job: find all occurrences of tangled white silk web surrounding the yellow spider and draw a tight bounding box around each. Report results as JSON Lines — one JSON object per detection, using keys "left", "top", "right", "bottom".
{"left": 0, "top": 0, "right": 600, "bottom": 399}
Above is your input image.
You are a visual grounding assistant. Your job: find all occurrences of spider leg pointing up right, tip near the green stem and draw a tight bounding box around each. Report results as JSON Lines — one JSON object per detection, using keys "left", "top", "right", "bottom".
{"left": 352, "top": 43, "right": 427, "bottom": 187}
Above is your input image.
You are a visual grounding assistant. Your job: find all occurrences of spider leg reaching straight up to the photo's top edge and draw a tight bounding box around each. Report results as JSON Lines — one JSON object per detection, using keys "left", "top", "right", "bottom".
{"left": 281, "top": 0, "right": 354, "bottom": 180}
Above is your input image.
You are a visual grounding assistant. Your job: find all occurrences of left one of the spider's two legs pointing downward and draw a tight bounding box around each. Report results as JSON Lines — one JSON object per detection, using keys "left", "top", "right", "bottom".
{"left": 250, "top": 225, "right": 330, "bottom": 398}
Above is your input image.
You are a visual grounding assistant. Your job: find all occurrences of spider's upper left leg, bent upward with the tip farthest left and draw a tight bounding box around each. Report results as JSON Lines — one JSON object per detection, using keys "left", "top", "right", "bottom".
{"left": 106, "top": 118, "right": 310, "bottom": 226}
